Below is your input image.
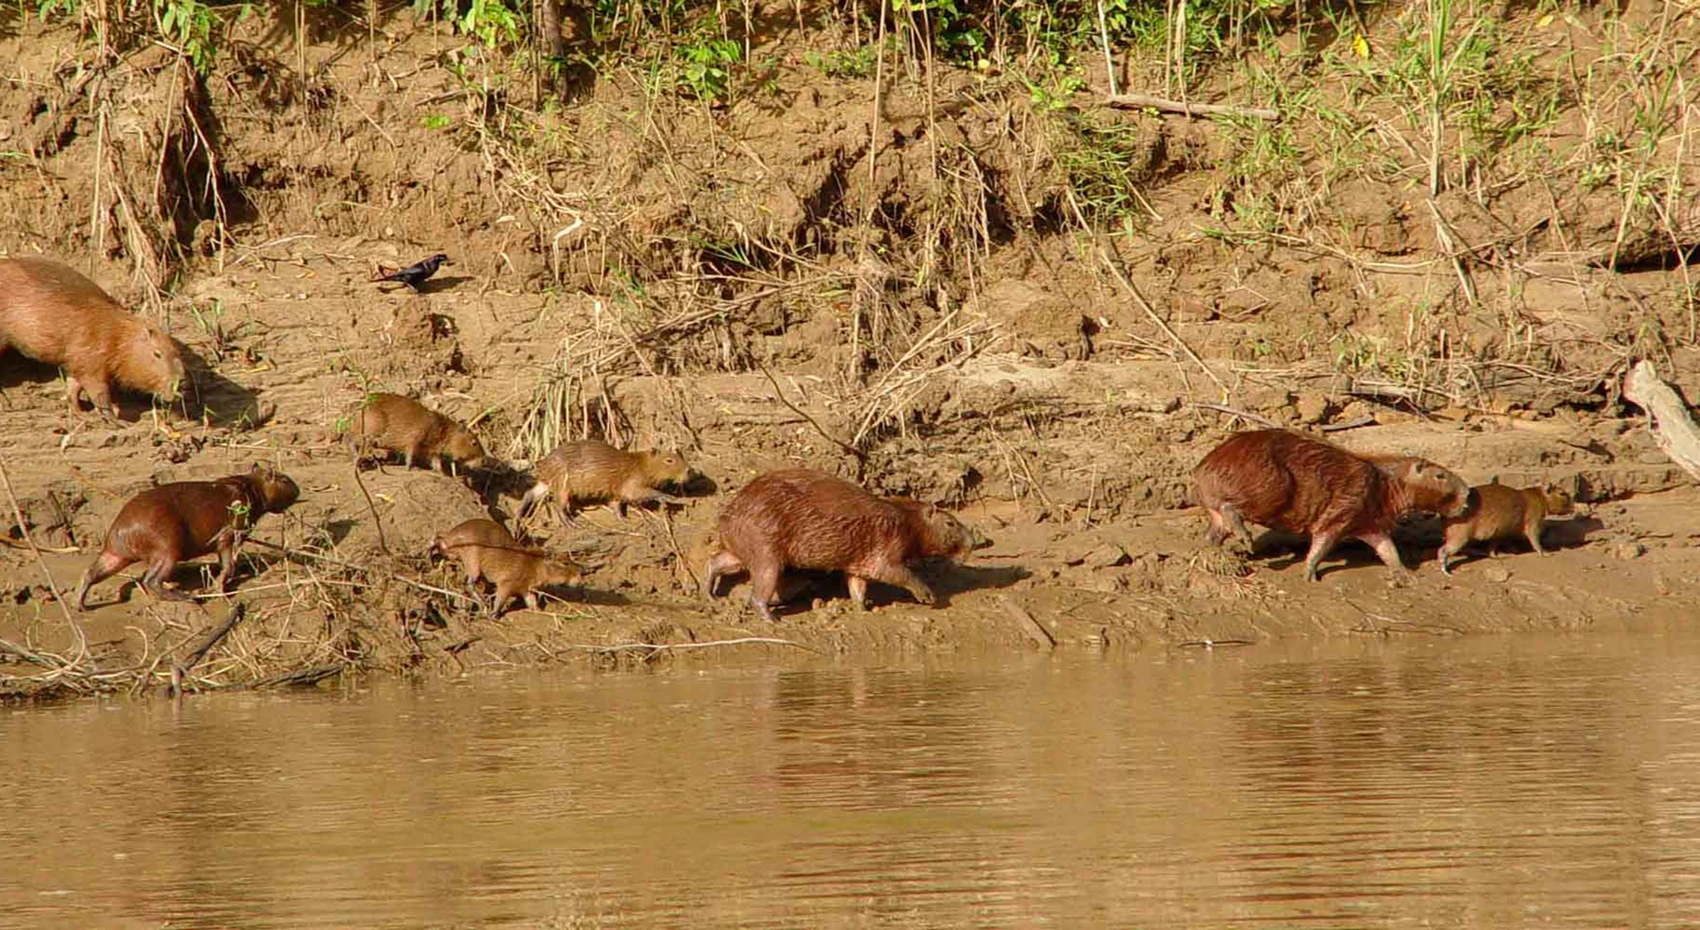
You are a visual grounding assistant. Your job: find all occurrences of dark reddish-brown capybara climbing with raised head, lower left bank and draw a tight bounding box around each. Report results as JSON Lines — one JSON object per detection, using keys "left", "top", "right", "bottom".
{"left": 77, "top": 464, "right": 301, "bottom": 610}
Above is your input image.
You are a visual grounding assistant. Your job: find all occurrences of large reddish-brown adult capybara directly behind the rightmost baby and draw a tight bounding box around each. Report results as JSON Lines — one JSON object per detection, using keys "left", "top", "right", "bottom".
{"left": 1192, "top": 430, "right": 1471, "bottom": 581}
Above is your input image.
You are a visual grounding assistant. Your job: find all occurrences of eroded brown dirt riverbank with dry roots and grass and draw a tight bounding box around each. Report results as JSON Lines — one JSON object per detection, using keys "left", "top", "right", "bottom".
{"left": 0, "top": 5, "right": 1700, "bottom": 690}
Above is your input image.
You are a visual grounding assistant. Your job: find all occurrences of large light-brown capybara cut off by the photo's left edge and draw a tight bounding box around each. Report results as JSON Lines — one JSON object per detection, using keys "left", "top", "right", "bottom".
{"left": 0, "top": 258, "right": 184, "bottom": 417}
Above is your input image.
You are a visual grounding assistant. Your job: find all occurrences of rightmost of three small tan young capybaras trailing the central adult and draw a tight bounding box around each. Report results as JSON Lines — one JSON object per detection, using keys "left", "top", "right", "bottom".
{"left": 519, "top": 439, "right": 690, "bottom": 522}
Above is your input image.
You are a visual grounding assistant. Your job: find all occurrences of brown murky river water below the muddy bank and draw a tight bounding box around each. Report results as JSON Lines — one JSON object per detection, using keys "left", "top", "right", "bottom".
{"left": 0, "top": 634, "right": 1700, "bottom": 928}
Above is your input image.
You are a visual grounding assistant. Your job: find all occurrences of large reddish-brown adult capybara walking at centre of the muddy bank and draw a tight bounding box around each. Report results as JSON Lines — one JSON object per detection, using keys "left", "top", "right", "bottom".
{"left": 702, "top": 468, "right": 984, "bottom": 622}
